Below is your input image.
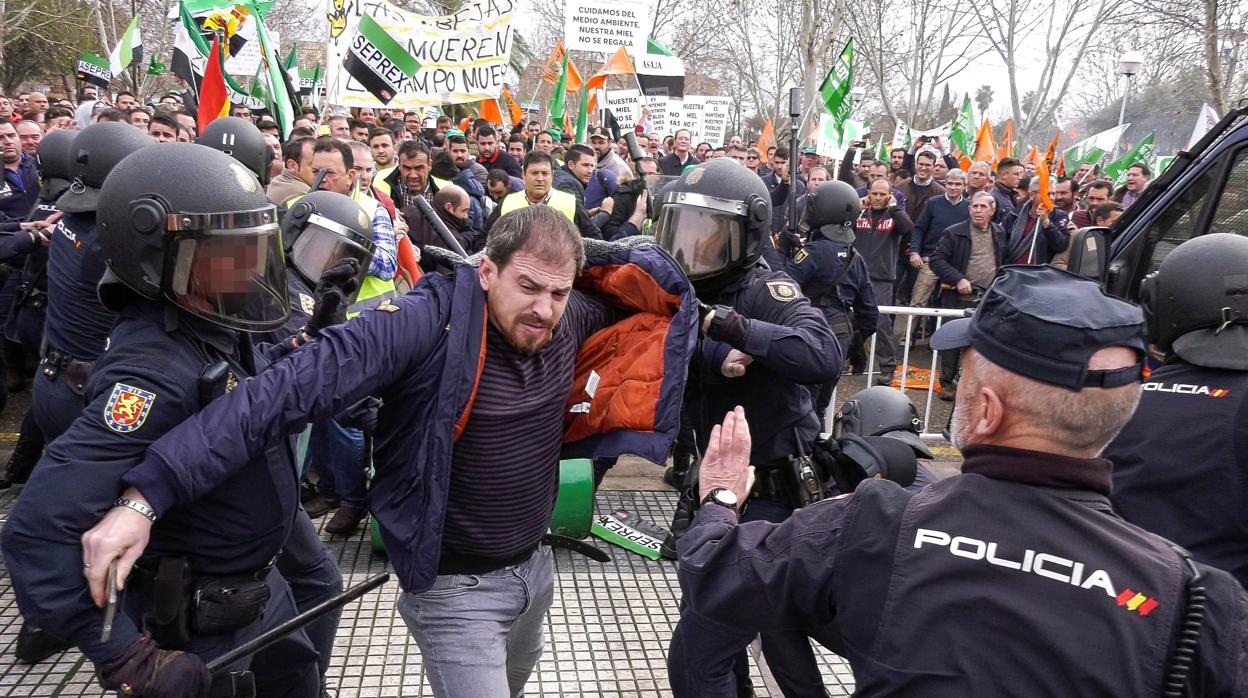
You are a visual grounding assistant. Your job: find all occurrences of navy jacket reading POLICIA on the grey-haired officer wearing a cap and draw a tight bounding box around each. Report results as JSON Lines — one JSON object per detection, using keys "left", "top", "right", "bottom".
{"left": 678, "top": 446, "right": 1248, "bottom": 698}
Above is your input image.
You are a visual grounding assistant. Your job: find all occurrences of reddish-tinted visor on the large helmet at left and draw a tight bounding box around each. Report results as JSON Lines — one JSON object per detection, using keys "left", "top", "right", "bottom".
{"left": 165, "top": 207, "right": 290, "bottom": 332}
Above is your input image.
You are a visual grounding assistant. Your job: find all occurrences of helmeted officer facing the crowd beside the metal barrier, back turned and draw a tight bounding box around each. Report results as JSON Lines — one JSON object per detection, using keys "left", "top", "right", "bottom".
{"left": 785, "top": 181, "right": 880, "bottom": 431}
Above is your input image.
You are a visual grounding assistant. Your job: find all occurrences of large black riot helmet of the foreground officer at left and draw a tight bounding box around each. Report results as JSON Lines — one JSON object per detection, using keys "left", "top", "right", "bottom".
{"left": 96, "top": 142, "right": 290, "bottom": 331}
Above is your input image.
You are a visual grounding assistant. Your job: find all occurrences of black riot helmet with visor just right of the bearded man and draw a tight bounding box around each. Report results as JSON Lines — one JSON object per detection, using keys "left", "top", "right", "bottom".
{"left": 655, "top": 157, "right": 771, "bottom": 291}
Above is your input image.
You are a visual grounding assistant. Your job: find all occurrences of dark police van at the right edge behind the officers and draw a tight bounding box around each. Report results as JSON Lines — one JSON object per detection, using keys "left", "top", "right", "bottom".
{"left": 1067, "top": 100, "right": 1248, "bottom": 294}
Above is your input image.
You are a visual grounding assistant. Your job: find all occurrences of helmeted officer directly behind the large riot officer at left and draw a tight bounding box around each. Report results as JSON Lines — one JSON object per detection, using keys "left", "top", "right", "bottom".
{"left": 31, "top": 122, "right": 154, "bottom": 442}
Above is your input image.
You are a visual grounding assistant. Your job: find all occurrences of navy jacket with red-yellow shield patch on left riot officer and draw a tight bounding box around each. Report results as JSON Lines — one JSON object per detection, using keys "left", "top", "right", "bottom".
{"left": 0, "top": 301, "right": 298, "bottom": 663}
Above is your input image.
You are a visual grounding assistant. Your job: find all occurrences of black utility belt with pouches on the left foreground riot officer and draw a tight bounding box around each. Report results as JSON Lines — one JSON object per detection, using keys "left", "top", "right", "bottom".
{"left": 131, "top": 557, "right": 272, "bottom": 649}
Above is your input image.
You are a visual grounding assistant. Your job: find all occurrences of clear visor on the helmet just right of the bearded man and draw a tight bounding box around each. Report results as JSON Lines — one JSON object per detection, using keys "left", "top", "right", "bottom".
{"left": 656, "top": 204, "right": 745, "bottom": 281}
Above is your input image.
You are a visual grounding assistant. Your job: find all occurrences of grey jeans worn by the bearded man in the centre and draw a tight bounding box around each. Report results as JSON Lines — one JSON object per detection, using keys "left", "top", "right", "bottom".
{"left": 398, "top": 546, "right": 554, "bottom": 698}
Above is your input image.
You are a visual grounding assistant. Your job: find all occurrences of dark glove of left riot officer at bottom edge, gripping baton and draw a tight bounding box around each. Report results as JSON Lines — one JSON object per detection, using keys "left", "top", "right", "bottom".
{"left": 100, "top": 636, "right": 212, "bottom": 698}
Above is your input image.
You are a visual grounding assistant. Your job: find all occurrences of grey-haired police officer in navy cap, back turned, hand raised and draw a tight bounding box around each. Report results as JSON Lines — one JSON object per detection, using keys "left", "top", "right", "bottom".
{"left": 669, "top": 266, "right": 1248, "bottom": 697}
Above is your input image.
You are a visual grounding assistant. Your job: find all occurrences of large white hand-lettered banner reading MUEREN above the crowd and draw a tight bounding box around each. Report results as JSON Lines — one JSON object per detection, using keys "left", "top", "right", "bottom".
{"left": 326, "top": 0, "right": 515, "bottom": 109}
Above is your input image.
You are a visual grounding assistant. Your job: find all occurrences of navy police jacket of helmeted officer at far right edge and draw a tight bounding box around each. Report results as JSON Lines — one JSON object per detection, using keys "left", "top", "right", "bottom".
{"left": 1103, "top": 358, "right": 1248, "bottom": 584}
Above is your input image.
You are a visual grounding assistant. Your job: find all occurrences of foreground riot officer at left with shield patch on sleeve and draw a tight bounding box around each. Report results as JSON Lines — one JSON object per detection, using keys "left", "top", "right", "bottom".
{"left": 0, "top": 144, "right": 331, "bottom": 698}
